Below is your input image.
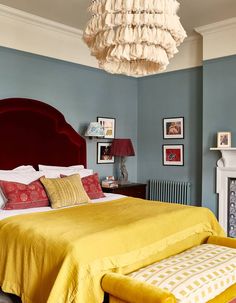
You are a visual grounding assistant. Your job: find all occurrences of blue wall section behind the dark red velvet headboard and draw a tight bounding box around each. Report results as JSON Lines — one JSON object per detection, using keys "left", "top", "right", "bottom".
{"left": 0, "top": 48, "right": 137, "bottom": 181}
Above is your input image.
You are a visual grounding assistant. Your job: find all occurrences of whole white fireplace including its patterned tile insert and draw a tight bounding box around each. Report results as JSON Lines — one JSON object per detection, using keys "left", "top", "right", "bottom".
{"left": 211, "top": 147, "right": 236, "bottom": 238}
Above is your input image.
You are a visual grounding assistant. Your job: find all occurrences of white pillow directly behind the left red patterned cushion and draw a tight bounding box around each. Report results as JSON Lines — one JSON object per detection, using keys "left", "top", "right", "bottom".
{"left": 0, "top": 171, "right": 44, "bottom": 185}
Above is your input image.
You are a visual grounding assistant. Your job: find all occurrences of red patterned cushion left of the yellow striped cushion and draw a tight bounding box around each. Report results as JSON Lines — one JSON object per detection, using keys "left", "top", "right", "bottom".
{"left": 0, "top": 180, "right": 49, "bottom": 210}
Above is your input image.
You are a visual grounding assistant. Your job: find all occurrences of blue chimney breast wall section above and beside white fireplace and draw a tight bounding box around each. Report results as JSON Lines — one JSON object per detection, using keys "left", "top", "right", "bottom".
{"left": 202, "top": 56, "right": 236, "bottom": 213}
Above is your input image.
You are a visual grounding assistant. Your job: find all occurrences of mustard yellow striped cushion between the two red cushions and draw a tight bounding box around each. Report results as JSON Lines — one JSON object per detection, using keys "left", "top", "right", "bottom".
{"left": 40, "top": 174, "right": 90, "bottom": 208}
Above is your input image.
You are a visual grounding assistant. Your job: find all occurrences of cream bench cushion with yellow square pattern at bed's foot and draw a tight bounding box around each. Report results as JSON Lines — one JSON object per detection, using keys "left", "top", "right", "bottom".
{"left": 129, "top": 244, "right": 236, "bottom": 303}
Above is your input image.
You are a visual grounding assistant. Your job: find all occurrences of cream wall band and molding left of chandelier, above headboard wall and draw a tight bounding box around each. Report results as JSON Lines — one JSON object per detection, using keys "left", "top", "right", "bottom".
{"left": 0, "top": 5, "right": 98, "bottom": 68}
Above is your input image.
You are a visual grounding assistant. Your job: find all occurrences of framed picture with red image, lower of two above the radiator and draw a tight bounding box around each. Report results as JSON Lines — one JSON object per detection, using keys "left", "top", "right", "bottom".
{"left": 162, "top": 144, "right": 184, "bottom": 166}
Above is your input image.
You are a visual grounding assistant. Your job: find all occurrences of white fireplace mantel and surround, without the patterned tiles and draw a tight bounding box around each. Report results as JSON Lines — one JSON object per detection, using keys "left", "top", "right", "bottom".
{"left": 210, "top": 147, "right": 236, "bottom": 232}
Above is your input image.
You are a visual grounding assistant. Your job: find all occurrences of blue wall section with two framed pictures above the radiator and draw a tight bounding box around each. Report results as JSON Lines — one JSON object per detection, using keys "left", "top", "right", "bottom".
{"left": 138, "top": 68, "right": 202, "bottom": 205}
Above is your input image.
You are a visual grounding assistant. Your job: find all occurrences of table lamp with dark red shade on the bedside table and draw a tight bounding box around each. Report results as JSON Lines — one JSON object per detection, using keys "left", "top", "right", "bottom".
{"left": 110, "top": 139, "right": 135, "bottom": 184}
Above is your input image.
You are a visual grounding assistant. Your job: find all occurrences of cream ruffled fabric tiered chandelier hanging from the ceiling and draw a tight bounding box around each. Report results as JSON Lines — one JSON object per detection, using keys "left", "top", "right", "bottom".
{"left": 83, "top": 0, "right": 186, "bottom": 76}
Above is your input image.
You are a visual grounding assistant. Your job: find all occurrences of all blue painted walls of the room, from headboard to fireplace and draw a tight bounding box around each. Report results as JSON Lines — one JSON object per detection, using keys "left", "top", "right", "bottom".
{"left": 0, "top": 48, "right": 236, "bottom": 213}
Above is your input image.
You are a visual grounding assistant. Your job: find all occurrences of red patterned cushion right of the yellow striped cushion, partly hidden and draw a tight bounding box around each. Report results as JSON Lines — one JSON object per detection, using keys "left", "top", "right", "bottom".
{"left": 81, "top": 173, "right": 105, "bottom": 199}
